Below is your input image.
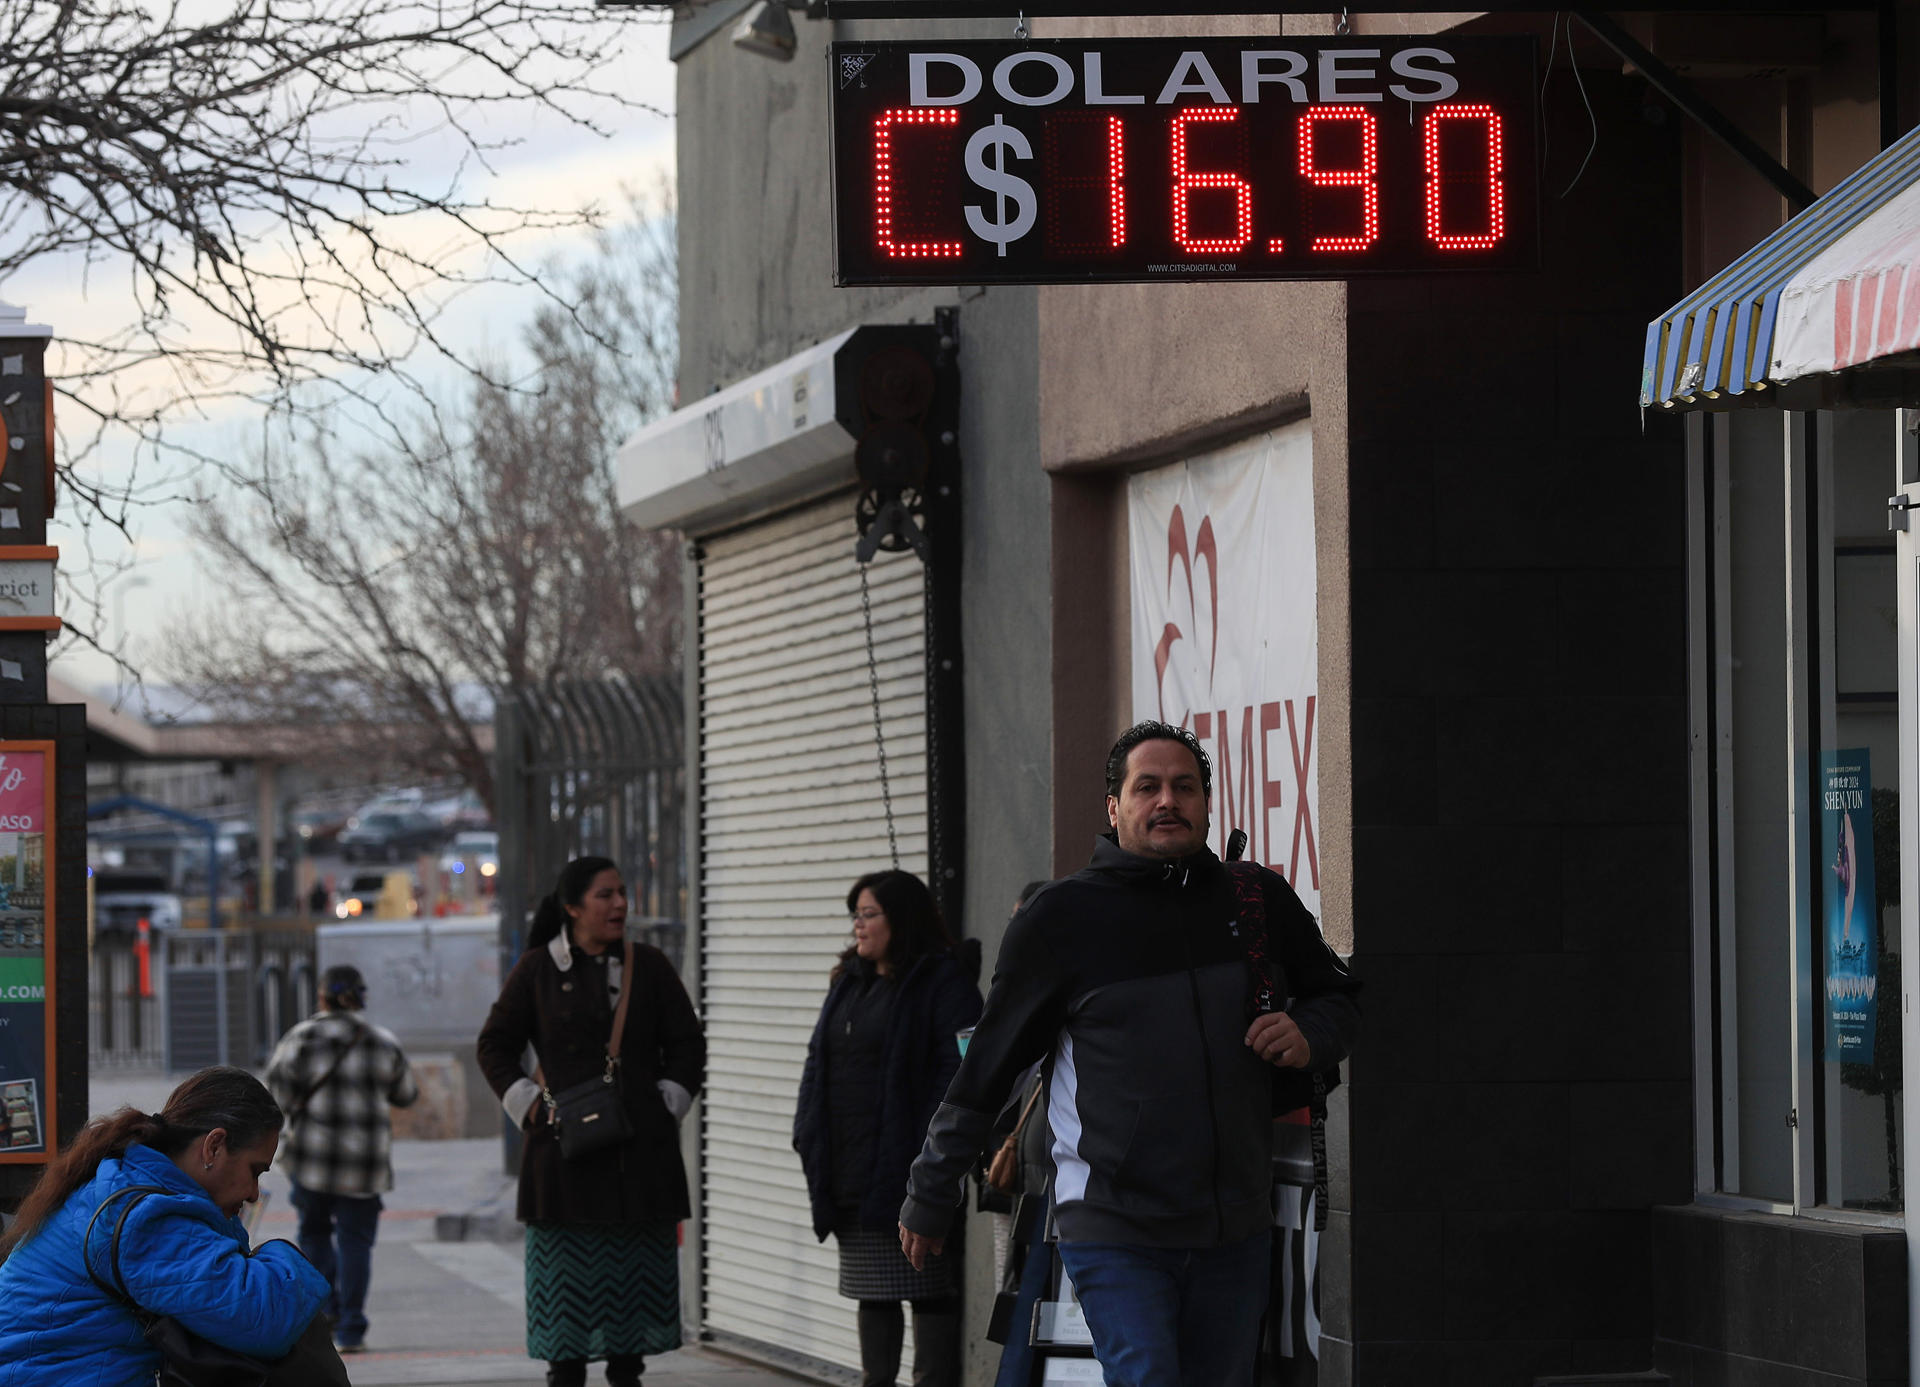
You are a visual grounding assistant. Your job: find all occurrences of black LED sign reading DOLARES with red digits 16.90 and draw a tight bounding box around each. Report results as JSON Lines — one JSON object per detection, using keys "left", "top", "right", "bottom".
{"left": 833, "top": 35, "right": 1540, "bottom": 284}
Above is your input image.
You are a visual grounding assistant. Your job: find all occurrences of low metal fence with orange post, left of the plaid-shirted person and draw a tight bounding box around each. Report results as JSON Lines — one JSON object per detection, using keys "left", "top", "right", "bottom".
{"left": 86, "top": 930, "right": 319, "bottom": 1074}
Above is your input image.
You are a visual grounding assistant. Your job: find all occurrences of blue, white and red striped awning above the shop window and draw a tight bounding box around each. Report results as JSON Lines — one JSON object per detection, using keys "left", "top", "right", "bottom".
{"left": 1640, "top": 127, "right": 1920, "bottom": 409}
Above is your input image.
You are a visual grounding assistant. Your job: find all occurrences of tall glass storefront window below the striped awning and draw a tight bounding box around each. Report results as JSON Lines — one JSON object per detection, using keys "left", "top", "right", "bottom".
{"left": 1690, "top": 409, "right": 1905, "bottom": 1212}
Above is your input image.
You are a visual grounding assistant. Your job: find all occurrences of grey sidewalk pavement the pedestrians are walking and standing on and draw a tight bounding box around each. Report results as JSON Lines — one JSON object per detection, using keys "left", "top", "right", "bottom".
{"left": 90, "top": 1070, "right": 797, "bottom": 1387}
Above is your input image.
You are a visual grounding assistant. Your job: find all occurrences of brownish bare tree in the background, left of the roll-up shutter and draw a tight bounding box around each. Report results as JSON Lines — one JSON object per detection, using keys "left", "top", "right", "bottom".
{"left": 165, "top": 189, "right": 680, "bottom": 803}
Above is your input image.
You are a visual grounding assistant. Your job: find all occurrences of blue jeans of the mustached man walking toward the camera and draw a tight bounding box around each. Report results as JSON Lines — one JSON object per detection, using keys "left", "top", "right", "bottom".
{"left": 1060, "top": 1231, "right": 1273, "bottom": 1387}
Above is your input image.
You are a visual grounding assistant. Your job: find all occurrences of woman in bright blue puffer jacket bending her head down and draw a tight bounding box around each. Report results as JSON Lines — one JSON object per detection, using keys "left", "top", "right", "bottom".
{"left": 0, "top": 1066, "right": 326, "bottom": 1387}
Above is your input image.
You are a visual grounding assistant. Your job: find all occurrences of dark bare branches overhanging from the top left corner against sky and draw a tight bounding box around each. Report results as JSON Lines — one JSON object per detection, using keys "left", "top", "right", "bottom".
{"left": 0, "top": 0, "right": 691, "bottom": 664}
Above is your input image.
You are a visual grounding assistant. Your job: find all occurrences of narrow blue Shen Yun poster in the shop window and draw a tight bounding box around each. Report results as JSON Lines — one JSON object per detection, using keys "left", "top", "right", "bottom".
{"left": 1820, "top": 747, "right": 1880, "bottom": 1064}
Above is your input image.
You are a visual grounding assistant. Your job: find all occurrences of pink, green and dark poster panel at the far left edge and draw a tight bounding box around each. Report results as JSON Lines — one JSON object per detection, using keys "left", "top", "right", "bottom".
{"left": 0, "top": 742, "right": 54, "bottom": 1162}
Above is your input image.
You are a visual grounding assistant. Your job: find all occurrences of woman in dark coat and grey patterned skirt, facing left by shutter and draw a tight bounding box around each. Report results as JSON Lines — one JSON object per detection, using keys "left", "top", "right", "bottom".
{"left": 793, "top": 870, "right": 979, "bottom": 1387}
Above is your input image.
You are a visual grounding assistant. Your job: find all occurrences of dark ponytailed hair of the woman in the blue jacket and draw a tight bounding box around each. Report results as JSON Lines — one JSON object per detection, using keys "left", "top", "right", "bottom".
{"left": 0, "top": 1064, "right": 286, "bottom": 1258}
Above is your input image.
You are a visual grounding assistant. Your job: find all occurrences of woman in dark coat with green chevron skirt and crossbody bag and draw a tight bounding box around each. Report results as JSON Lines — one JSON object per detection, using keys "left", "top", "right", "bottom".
{"left": 480, "top": 857, "right": 707, "bottom": 1387}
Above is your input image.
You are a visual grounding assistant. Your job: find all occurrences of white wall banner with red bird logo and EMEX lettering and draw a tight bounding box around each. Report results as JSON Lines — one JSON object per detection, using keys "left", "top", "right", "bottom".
{"left": 1127, "top": 421, "right": 1319, "bottom": 916}
